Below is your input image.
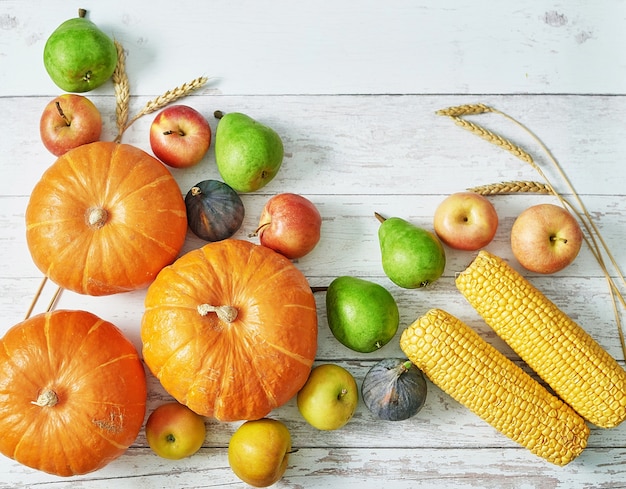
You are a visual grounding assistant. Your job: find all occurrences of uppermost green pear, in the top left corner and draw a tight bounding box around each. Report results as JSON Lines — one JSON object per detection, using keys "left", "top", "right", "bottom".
{"left": 43, "top": 9, "right": 117, "bottom": 92}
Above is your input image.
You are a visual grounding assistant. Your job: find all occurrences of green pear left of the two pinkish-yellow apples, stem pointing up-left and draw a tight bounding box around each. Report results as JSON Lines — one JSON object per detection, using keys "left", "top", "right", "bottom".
{"left": 375, "top": 213, "right": 446, "bottom": 289}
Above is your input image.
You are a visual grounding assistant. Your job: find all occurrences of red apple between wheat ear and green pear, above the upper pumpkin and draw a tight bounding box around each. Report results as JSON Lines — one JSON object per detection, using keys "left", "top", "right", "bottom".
{"left": 150, "top": 105, "right": 211, "bottom": 168}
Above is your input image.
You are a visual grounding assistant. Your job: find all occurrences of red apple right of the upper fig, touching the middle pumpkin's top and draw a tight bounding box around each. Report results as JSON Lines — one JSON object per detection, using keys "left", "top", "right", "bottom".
{"left": 256, "top": 193, "right": 322, "bottom": 259}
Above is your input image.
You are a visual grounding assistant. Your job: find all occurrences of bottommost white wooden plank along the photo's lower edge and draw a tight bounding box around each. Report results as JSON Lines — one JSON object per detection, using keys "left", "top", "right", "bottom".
{"left": 0, "top": 446, "right": 626, "bottom": 489}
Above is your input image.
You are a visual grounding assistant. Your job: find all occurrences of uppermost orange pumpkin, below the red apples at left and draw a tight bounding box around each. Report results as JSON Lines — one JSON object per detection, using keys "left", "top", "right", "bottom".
{"left": 26, "top": 141, "right": 187, "bottom": 295}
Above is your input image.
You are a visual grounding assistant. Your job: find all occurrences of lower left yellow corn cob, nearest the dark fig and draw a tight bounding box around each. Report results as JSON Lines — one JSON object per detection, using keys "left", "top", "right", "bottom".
{"left": 400, "top": 309, "right": 589, "bottom": 465}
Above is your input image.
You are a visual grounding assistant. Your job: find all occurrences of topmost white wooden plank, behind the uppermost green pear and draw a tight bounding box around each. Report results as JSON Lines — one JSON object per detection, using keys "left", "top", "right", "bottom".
{"left": 0, "top": 0, "right": 626, "bottom": 95}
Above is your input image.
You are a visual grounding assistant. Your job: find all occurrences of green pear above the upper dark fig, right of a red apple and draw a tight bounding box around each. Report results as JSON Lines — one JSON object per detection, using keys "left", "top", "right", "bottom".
{"left": 215, "top": 112, "right": 284, "bottom": 192}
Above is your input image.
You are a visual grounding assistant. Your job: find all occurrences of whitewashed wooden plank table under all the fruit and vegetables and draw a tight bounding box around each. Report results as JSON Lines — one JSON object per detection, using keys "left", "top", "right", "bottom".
{"left": 0, "top": 0, "right": 626, "bottom": 489}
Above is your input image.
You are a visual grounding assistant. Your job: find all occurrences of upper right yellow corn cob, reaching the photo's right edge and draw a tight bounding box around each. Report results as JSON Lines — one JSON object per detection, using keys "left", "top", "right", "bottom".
{"left": 456, "top": 250, "right": 626, "bottom": 428}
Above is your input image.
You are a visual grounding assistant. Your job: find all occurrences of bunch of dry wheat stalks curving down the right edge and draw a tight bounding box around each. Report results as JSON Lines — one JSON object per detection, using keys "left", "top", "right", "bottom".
{"left": 437, "top": 104, "right": 626, "bottom": 359}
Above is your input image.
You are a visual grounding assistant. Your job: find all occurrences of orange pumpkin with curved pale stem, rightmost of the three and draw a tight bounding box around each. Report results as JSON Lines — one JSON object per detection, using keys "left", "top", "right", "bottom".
{"left": 141, "top": 239, "right": 317, "bottom": 421}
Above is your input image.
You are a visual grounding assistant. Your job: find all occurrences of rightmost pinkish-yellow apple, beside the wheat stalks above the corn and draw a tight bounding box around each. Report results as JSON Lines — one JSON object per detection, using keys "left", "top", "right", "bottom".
{"left": 511, "top": 200, "right": 583, "bottom": 274}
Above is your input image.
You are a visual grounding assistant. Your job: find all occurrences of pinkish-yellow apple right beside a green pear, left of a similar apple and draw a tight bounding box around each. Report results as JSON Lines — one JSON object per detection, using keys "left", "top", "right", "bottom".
{"left": 434, "top": 192, "right": 498, "bottom": 251}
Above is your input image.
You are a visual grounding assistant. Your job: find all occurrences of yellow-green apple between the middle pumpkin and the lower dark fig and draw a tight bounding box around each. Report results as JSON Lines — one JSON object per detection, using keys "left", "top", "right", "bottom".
{"left": 297, "top": 363, "right": 359, "bottom": 431}
